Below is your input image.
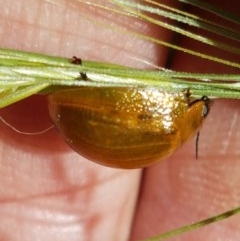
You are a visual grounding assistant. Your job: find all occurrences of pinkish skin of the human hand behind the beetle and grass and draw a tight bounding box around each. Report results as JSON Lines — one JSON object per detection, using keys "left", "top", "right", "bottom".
{"left": 0, "top": 0, "right": 240, "bottom": 241}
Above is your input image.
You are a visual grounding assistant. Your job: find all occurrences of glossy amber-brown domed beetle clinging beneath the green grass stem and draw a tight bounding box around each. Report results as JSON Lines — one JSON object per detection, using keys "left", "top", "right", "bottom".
{"left": 48, "top": 87, "right": 210, "bottom": 168}
